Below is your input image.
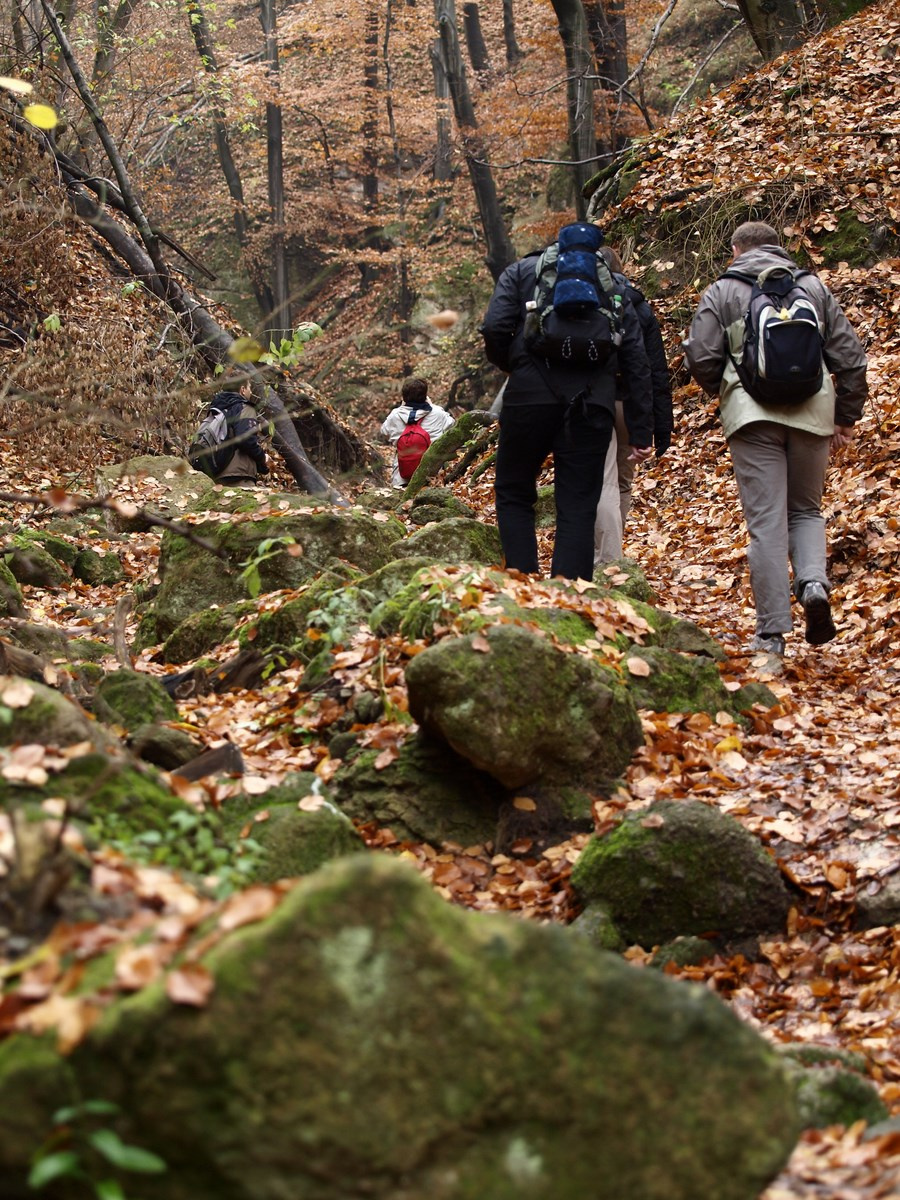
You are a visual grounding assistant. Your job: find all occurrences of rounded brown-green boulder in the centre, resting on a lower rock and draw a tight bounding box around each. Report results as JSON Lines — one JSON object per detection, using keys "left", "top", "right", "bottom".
{"left": 406, "top": 625, "right": 643, "bottom": 788}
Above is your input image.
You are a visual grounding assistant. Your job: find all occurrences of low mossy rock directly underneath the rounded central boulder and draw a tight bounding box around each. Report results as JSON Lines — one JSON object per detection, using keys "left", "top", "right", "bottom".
{"left": 331, "top": 733, "right": 504, "bottom": 846}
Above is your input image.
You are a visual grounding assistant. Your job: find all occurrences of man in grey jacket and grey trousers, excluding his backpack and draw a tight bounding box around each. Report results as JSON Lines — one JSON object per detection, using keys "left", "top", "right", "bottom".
{"left": 684, "top": 221, "right": 868, "bottom": 655}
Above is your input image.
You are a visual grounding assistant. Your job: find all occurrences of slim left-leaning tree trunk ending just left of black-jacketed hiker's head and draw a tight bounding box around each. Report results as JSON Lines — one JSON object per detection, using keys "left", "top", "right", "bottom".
{"left": 436, "top": 0, "right": 516, "bottom": 280}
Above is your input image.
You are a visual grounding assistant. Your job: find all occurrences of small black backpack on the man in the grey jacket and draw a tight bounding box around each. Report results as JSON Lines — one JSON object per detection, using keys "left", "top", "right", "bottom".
{"left": 721, "top": 266, "right": 824, "bottom": 406}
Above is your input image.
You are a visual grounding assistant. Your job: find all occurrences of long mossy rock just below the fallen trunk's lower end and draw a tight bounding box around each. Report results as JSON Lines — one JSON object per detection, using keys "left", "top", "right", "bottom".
{"left": 154, "top": 509, "right": 403, "bottom": 638}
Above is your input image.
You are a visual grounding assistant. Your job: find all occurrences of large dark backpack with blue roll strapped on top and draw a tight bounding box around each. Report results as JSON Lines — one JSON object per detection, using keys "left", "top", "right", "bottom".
{"left": 524, "top": 222, "right": 622, "bottom": 368}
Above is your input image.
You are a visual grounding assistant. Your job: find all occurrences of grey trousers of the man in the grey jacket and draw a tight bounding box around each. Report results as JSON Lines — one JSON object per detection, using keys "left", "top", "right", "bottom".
{"left": 728, "top": 421, "right": 830, "bottom": 637}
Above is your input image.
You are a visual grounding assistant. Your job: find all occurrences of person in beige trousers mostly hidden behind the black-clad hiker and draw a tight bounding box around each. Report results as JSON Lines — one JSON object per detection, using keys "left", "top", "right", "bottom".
{"left": 594, "top": 246, "right": 674, "bottom": 565}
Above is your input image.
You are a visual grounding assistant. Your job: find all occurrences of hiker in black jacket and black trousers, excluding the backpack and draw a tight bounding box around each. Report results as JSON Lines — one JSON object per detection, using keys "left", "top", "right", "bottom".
{"left": 481, "top": 226, "right": 653, "bottom": 580}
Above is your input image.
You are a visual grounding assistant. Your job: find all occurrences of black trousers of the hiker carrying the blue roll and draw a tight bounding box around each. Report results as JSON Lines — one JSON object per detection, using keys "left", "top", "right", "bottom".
{"left": 494, "top": 403, "right": 613, "bottom": 580}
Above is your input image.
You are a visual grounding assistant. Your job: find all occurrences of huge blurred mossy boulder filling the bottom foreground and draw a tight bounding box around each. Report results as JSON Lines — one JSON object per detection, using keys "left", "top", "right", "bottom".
{"left": 0, "top": 854, "right": 799, "bottom": 1200}
